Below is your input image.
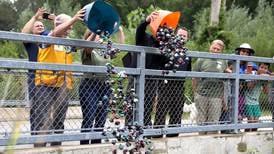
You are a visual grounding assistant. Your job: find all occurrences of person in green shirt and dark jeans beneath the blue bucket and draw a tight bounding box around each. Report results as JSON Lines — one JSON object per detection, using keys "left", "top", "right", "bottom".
{"left": 79, "top": 26, "right": 125, "bottom": 144}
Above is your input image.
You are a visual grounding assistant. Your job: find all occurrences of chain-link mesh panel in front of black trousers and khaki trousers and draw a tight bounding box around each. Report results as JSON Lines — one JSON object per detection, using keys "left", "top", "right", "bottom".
{"left": 144, "top": 77, "right": 237, "bottom": 128}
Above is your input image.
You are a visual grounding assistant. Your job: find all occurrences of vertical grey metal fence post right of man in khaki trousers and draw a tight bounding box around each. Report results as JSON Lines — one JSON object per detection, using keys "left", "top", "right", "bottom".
{"left": 232, "top": 60, "right": 240, "bottom": 133}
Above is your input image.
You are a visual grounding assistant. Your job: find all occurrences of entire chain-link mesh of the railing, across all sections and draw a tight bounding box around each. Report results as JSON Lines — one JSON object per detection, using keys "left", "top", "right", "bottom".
{"left": 0, "top": 70, "right": 274, "bottom": 143}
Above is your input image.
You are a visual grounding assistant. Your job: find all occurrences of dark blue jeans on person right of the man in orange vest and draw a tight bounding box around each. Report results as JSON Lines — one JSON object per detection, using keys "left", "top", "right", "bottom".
{"left": 79, "top": 78, "right": 110, "bottom": 144}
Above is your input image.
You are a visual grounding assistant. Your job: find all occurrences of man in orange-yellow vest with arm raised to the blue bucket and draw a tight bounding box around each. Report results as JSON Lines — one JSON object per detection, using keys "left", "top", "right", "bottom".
{"left": 33, "top": 10, "right": 85, "bottom": 147}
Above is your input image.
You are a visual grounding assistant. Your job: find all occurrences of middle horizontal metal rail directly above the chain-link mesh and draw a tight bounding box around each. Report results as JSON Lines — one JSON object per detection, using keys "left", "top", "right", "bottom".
{"left": 0, "top": 59, "right": 274, "bottom": 80}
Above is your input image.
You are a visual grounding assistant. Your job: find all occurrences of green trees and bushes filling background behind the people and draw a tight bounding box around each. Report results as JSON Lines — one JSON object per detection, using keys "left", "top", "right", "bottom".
{"left": 0, "top": 0, "right": 274, "bottom": 59}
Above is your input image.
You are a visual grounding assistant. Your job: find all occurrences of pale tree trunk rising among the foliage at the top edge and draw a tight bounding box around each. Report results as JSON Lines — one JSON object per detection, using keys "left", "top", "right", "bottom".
{"left": 210, "top": 0, "right": 222, "bottom": 26}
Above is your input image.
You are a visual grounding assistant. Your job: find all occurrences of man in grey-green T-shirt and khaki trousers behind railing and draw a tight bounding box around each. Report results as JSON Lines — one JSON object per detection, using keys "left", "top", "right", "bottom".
{"left": 192, "top": 40, "right": 227, "bottom": 134}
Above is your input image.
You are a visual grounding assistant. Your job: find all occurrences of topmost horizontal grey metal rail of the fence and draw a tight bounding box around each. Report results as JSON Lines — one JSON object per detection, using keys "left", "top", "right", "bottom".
{"left": 0, "top": 31, "right": 274, "bottom": 63}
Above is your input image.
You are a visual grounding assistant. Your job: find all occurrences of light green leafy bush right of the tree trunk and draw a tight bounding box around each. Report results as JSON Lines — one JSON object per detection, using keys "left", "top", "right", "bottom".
{"left": 225, "top": 0, "right": 274, "bottom": 57}
